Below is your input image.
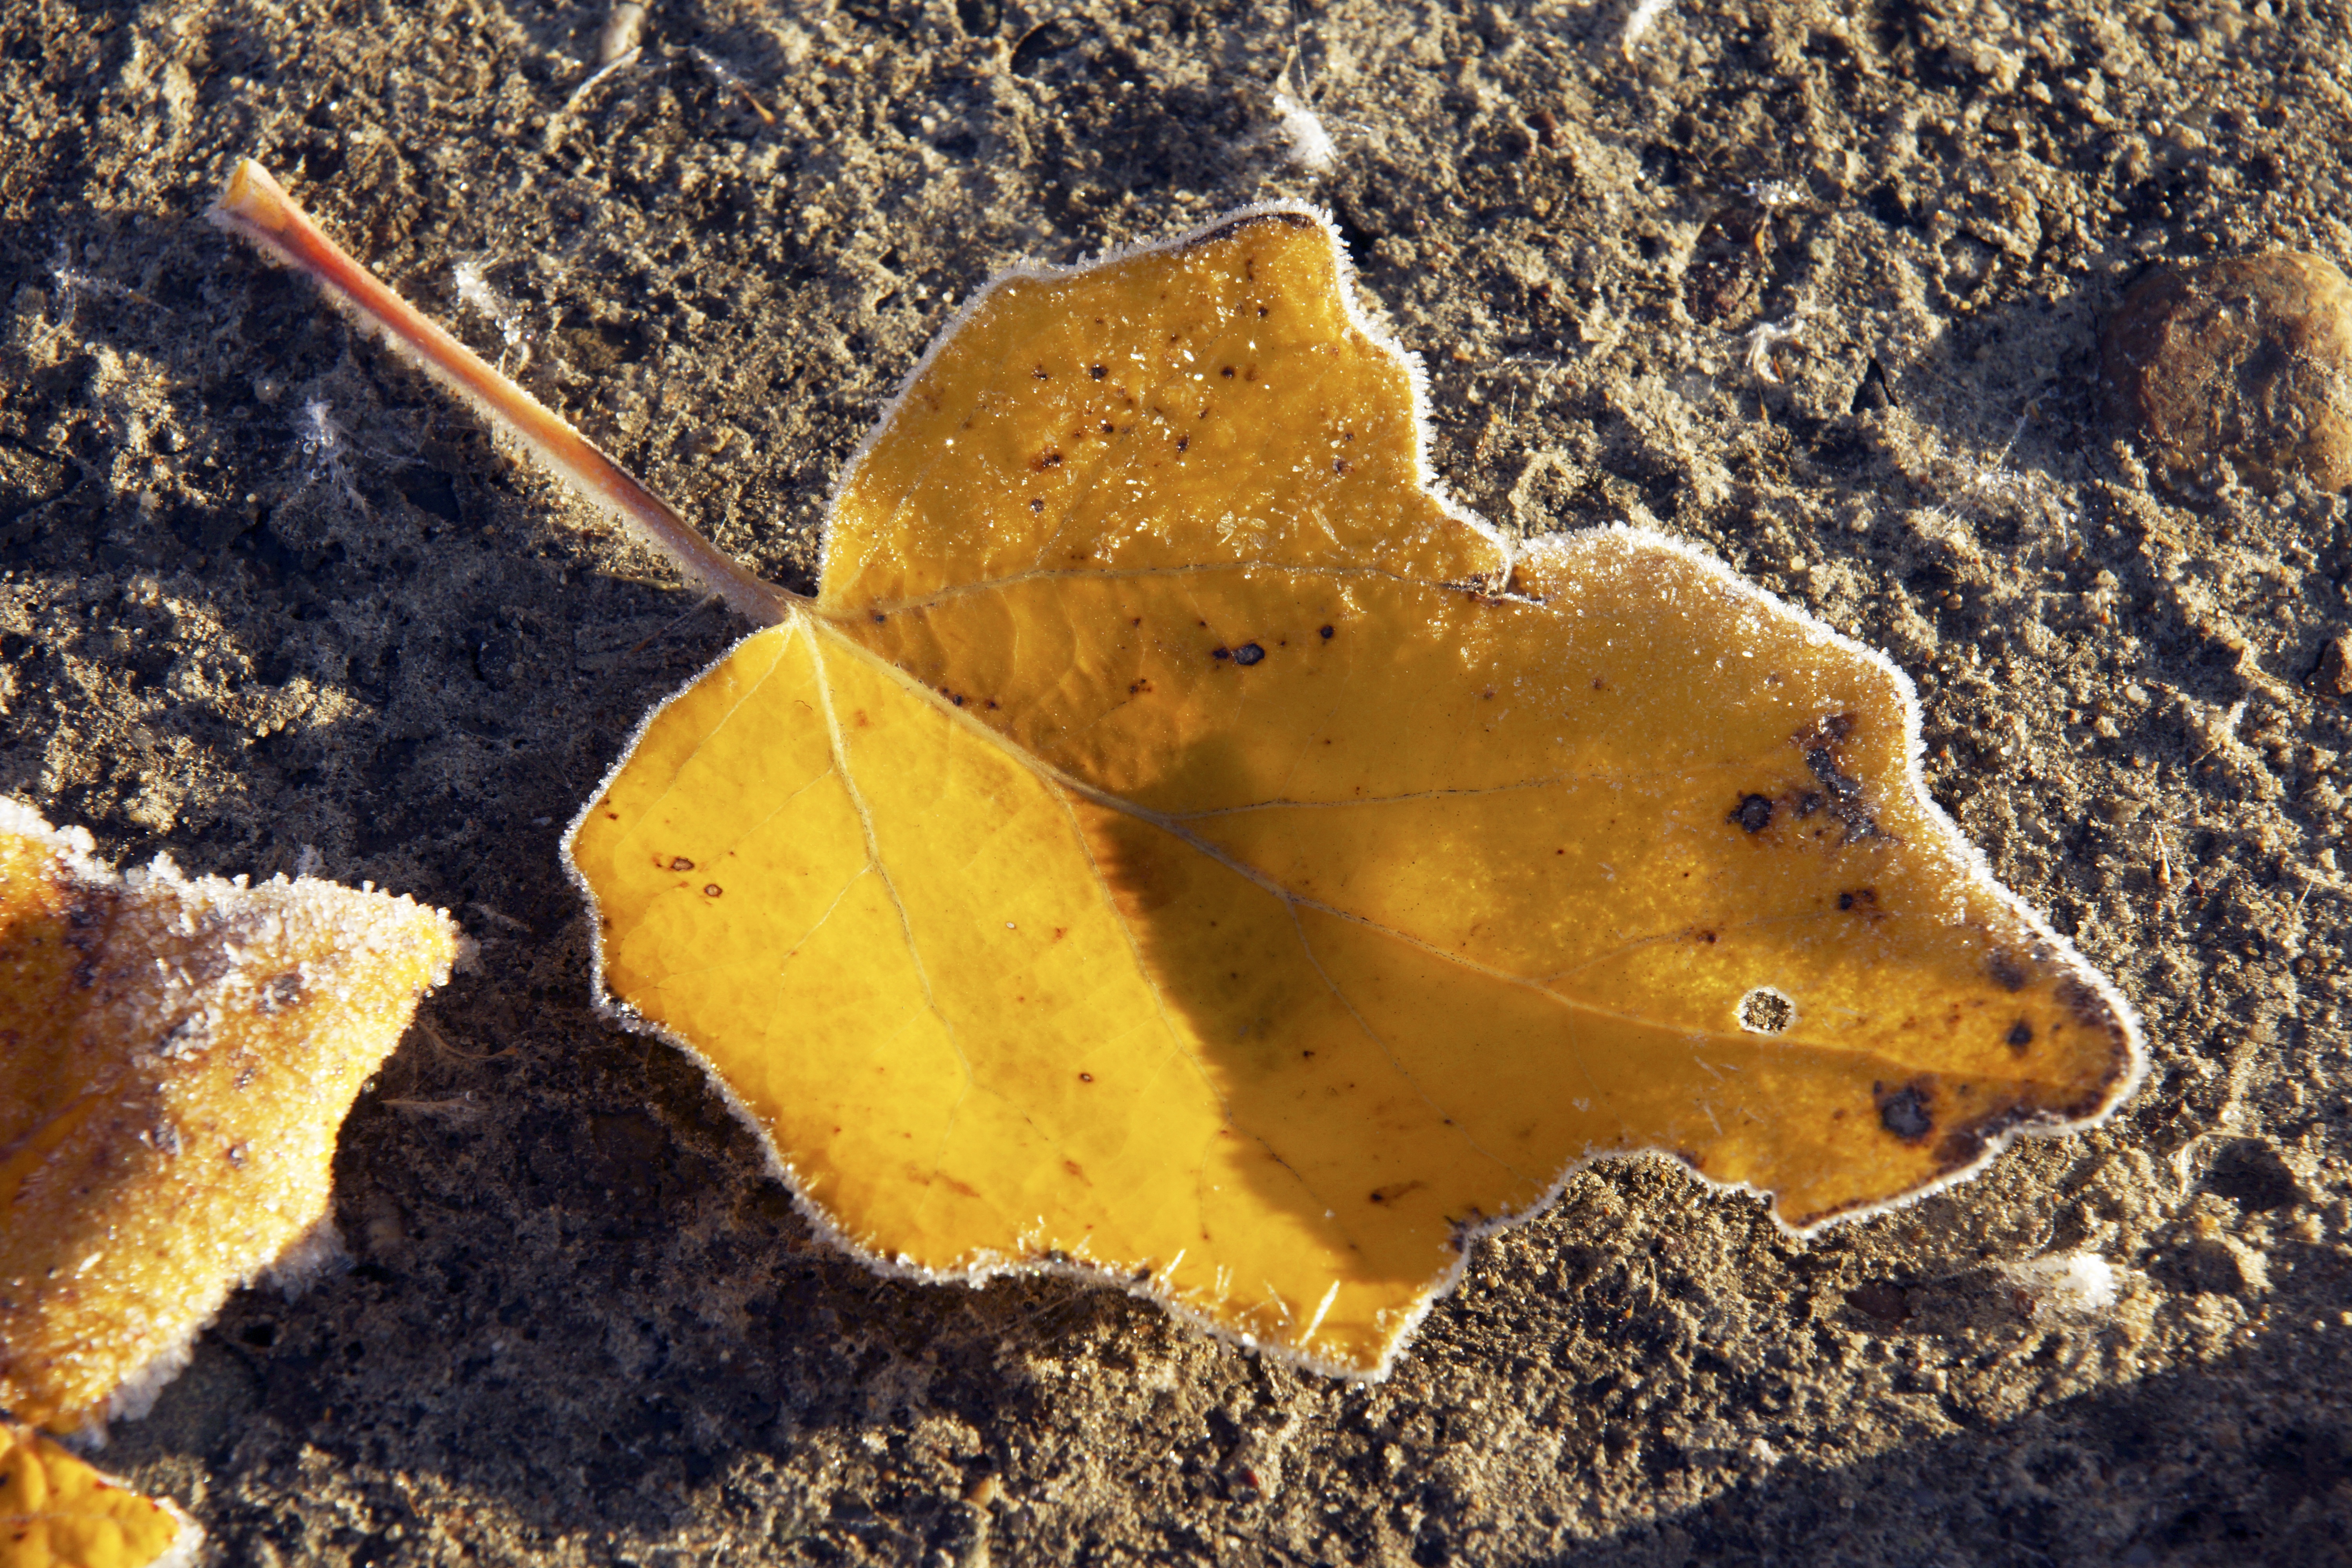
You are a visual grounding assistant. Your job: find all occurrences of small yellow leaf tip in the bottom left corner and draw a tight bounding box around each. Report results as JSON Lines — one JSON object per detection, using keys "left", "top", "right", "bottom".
{"left": 0, "top": 1422, "right": 205, "bottom": 1568}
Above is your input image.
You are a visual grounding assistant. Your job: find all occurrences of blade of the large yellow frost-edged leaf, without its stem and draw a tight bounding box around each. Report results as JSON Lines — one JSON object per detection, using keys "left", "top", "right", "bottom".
{"left": 569, "top": 209, "right": 2138, "bottom": 1373}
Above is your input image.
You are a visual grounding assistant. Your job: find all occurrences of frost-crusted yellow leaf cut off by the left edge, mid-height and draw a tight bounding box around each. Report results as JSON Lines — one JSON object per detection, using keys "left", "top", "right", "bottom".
{"left": 0, "top": 799, "right": 456, "bottom": 1429}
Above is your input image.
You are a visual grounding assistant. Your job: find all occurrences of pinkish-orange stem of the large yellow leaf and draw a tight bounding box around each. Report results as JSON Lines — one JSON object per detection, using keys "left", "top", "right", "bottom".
{"left": 209, "top": 158, "right": 802, "bottom": 625}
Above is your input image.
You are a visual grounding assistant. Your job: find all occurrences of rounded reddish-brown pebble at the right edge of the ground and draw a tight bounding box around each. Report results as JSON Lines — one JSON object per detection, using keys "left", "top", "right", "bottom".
{"left": 2103, "top": 252, "right": 2352, "bottom": 491}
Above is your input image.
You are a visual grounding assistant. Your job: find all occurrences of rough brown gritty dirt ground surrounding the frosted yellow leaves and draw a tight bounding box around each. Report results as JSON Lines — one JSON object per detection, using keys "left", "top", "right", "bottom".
{"left": 0, "top": 0, "right": 2352, "bottom": 1566}
